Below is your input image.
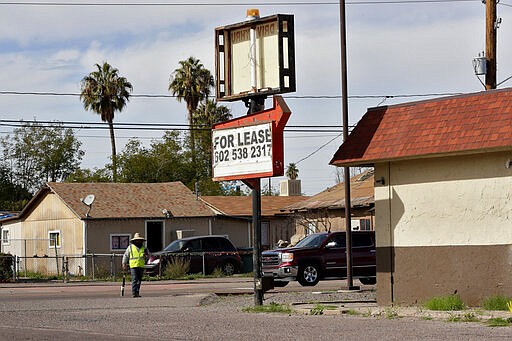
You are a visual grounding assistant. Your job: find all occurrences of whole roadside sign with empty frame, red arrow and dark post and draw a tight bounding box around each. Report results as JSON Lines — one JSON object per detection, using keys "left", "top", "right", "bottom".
{"left": 212, "top": 9, "right": 295, "bottom": 305}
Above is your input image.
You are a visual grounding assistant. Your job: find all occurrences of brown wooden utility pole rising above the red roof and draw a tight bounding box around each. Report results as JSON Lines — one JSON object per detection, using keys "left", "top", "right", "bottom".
{"left": 485, "top": 0, "right": 498, "bottom": 90}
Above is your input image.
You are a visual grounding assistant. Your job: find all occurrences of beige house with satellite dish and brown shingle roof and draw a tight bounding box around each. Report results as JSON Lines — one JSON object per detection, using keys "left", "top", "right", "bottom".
{"left": 1, "top": 182, "right": 214, "bottom": 270}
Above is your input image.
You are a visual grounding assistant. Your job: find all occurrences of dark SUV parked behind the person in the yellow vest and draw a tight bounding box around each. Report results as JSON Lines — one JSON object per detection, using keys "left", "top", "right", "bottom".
{"left": 145, "top": 235, "right": 242, "bottom": 275}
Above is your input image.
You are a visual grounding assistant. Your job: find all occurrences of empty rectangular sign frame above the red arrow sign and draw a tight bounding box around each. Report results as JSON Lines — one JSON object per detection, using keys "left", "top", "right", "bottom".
{"left": 215, "top": 14, "right": 295, "bottom": 101}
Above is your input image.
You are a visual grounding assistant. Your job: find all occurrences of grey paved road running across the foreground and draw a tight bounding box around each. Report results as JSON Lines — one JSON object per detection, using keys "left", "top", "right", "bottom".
{"left": 0, "top": 278, "right": 512, "bottom": 341}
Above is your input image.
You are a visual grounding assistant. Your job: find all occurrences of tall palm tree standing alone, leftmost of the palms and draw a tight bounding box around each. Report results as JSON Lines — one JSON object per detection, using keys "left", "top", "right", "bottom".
{"left": 80, "top": 62, "right": 133, "bottom": 182}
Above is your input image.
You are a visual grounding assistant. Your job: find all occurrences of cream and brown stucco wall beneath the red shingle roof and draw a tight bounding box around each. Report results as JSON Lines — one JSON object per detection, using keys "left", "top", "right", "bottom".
{"left": 375, "top": 152, "right": 512, "bottom": 304}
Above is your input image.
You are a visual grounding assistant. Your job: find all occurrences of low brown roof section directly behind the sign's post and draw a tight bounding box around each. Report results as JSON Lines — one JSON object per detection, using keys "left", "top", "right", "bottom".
{"left": 201, "top": 195, "right": 308, "bottom": 217}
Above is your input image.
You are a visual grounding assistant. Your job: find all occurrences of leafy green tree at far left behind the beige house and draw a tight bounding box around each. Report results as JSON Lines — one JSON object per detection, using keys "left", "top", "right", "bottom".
{"left": 0, "top": 122, "right": 84, "bottom": 193}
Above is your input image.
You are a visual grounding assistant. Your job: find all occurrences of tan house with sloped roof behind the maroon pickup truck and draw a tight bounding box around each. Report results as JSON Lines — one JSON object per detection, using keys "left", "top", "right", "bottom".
{"left": 283, "top": 169, "right": 375, "bottom": 242}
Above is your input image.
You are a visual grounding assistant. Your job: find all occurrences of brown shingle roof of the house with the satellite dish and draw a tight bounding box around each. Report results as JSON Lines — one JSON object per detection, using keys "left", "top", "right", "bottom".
{"left": 22, "top": 182, "right": 213, "bottom": 219}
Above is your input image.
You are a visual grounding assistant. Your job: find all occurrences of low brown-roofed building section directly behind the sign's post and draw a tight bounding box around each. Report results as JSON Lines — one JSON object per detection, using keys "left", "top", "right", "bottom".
{"left": 201, "top": 196, "right": 307, "bottom": 250}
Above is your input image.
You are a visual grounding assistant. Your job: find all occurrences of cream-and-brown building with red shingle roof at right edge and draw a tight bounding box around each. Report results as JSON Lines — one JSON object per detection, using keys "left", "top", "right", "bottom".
{"left": 331, "top": 89, "right": 512, "bottom": 305}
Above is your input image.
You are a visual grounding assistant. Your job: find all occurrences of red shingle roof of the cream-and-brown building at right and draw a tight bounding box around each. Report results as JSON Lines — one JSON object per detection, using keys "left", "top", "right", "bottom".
{"left": 330, "top": 88, "right": 512, "bottom": 166}
